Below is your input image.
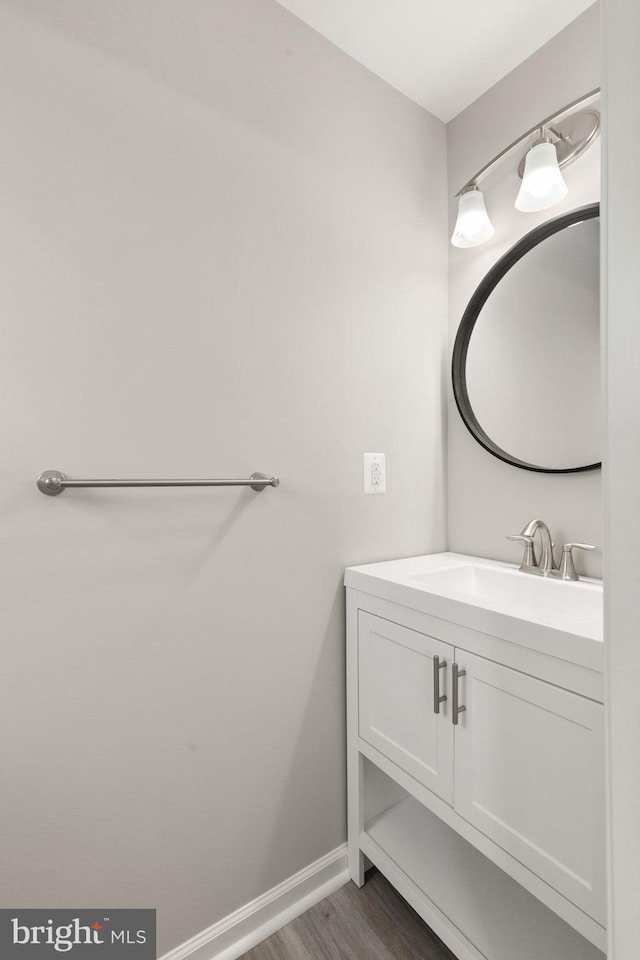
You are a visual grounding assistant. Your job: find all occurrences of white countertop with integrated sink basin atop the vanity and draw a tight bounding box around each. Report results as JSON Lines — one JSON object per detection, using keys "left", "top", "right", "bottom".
{"left": 345, "top": 553, "right": 604, "bottom": 670}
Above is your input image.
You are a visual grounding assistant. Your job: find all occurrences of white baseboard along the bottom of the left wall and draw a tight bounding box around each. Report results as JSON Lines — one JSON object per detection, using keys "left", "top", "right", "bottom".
{"left": 161, "top": 843, "right": 349, "bottom": 960}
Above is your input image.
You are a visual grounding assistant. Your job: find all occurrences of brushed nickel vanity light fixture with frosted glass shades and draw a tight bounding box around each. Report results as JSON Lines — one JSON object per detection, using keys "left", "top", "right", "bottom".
{"left": 451, "top": 89, "right": 600, "bottom": 247}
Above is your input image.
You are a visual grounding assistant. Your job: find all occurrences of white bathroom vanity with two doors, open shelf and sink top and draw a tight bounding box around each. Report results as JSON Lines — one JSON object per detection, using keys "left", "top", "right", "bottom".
{"left": 345, "top": 553, "right": 606, "bottom": 960}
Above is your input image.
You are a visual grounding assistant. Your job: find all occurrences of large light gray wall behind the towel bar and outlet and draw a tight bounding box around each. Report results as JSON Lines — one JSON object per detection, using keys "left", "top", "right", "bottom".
{"left": 0, "top": 0, "right": 448, "bottom": 952}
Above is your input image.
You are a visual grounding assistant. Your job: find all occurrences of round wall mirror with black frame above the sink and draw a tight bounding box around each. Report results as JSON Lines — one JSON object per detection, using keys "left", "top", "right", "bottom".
{"left": 452, "top": 203, "right": 601, "bottom": 473}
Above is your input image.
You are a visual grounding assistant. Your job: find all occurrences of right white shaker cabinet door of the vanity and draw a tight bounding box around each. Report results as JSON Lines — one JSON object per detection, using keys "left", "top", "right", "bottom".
{"left": 454, "top": 650, "right": 606, "bottom": 925}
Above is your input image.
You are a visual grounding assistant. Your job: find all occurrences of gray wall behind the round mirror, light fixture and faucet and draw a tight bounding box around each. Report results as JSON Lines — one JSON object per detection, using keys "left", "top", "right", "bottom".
{"left": 447, "top": 4, "right": 603, "bottom": 576}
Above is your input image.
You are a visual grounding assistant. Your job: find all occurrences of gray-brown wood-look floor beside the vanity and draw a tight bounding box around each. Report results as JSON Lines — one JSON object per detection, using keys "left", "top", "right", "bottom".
{"left": 240, "top": 870, "right": 456, "bottom": 960}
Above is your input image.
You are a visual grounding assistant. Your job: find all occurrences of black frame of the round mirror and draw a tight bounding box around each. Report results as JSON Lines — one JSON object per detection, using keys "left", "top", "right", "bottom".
{"left": 451, "top": 203, "right": 602, "bottom": 473}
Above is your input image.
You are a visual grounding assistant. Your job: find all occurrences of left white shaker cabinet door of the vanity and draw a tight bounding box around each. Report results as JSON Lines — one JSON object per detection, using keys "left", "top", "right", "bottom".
{"left": 358, "top": 611, "right": 454, "bottom": 803}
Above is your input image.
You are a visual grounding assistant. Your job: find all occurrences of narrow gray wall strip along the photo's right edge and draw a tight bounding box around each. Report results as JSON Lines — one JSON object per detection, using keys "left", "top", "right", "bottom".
{"left": 603, "top": 0, "right": 640, "bottom": 960}
